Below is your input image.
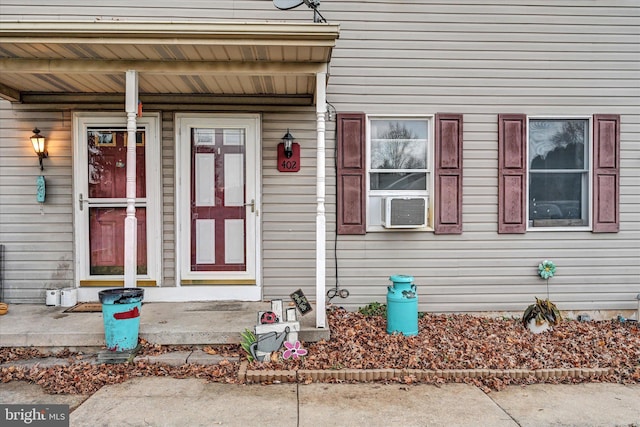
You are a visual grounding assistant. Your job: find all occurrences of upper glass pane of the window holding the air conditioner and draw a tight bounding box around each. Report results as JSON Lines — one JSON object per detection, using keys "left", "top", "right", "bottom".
{"left": 371, "top": 120, "right": 428, "bottom": 169}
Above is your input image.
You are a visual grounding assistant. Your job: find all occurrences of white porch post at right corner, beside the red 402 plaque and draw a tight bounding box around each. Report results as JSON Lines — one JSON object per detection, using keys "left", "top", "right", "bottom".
{"left": 316, "top": 72, "right": 327, "bottom": 328}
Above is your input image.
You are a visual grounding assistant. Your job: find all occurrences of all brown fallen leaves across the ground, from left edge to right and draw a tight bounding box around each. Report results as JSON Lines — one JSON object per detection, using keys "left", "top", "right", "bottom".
{"left": 0, "top": 308, "right": 640, "bottom": 394}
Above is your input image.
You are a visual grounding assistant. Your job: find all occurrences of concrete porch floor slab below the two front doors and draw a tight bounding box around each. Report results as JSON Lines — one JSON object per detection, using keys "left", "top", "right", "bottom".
{"left": 0, "top": 301, "right": 330, "bottom": 349}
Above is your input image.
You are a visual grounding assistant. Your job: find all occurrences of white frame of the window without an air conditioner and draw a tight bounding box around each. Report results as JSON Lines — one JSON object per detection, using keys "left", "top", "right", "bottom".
{"left": 525, "top": 115, "right": 593, "bottom": 232}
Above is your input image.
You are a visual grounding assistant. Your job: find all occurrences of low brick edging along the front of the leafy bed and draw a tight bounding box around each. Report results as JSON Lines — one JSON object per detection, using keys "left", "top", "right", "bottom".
{"left": 238, "top": 368, "right": 613, "bottom": 383}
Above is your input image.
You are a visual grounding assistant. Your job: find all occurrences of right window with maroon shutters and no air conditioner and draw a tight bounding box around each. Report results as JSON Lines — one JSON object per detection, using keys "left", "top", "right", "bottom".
{"left": 498, "top": 114, "right": 620, "bottom": 233}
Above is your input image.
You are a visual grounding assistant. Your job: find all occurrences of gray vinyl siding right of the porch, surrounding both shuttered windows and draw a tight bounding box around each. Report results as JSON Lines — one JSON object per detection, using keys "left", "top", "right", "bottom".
{"left": 325, "top": 2, "right": 640, "bottom": 311}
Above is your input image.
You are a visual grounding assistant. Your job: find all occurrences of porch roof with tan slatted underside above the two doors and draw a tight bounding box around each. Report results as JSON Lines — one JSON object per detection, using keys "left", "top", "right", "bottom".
{"left": 0, "top": 21, "right": 339, "bottom": 105}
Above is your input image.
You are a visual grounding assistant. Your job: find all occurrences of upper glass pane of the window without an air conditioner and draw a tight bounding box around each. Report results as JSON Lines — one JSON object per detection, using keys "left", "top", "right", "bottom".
{"left": 529, "top": 119, "right": 589, "bottom": 170}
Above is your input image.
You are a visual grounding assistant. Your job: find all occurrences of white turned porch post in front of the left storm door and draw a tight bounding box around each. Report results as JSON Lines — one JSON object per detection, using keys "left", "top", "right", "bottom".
{"left": 124, "top": 70, "right": 138, "bottom": 288}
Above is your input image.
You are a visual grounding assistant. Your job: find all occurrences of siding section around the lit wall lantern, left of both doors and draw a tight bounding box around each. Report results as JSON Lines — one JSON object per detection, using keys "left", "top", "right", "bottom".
{"left": 0, "top": 105, "right": 74, "bottom": 302}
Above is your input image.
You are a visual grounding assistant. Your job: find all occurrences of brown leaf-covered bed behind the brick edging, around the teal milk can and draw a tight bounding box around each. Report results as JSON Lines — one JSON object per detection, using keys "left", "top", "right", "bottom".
{"left": 248, "top": 309, "right": 640, "bottom": 391}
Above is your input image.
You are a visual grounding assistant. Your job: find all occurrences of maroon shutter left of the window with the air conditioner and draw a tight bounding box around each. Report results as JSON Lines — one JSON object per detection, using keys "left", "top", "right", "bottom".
{"left": 337, "top": 113, "right": 367, "bottom": 234}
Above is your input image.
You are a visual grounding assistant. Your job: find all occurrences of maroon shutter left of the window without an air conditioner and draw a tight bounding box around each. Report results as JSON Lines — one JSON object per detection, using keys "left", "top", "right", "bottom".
{"left": 498, "top": 114, "right": 527, "bottom": 233}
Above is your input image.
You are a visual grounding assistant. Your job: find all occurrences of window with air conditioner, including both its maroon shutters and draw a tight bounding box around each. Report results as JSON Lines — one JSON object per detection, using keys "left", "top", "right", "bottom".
{"left": 337, "top": 113, "right": 462, "bottom": 234}
